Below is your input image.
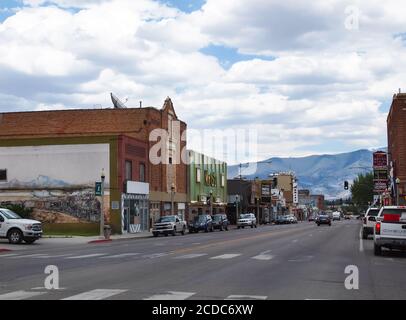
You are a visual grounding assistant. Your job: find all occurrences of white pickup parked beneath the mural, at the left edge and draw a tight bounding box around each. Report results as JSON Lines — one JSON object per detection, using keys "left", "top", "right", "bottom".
{"left": 0, "top": 208, "right": 42, "bottom": 244}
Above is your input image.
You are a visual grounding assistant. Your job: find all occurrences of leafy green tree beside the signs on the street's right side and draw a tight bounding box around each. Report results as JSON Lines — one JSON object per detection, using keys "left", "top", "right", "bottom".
{"left": 351, "top": 172, "right": 374, "bottom": 208}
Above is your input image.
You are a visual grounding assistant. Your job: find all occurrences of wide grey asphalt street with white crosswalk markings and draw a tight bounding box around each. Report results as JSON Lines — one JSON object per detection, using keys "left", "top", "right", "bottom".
{"left": 0, "top": 220, "right": 406, "bottom": 300}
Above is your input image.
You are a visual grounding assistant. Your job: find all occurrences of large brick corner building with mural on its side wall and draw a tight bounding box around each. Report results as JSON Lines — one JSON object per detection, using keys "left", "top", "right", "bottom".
{"left": 0, "top": 98, "right": 187, "bottom": 232}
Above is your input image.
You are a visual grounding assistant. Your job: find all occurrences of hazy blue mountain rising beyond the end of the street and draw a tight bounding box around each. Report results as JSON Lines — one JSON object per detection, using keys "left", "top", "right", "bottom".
{"left": 228, "top": 148, "right": 386, "bottom": 199}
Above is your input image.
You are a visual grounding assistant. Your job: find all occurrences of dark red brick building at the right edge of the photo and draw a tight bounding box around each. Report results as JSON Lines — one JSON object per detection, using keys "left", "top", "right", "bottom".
{"left": 387, "top": 93, "right": 406, "bottom": 204}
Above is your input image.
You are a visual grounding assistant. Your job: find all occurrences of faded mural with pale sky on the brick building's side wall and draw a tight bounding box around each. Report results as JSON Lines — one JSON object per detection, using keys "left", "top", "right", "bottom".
{"left": 0, "top": 144, "right": 109, "bottom": 223}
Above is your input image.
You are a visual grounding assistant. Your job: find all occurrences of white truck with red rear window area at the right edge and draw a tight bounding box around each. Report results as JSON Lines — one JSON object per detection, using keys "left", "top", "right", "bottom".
{"left": 374, "top": 206, "right": 406, "bottom": 256}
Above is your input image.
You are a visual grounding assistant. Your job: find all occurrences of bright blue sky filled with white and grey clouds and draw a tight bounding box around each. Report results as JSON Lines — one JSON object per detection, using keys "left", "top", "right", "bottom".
{"left": 0, "top": 0, "right": 406, "bottom": 159}
